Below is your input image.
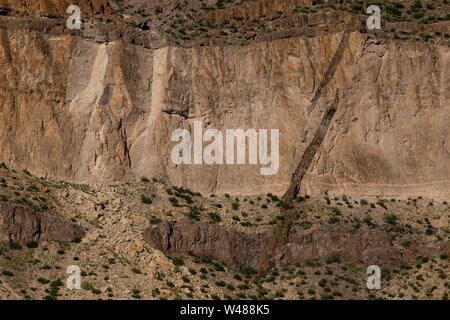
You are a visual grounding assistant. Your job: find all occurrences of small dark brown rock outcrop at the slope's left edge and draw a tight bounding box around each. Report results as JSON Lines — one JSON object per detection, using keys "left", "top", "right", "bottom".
{"left": 0, "top": 203, "right": 84, "bottom": 244}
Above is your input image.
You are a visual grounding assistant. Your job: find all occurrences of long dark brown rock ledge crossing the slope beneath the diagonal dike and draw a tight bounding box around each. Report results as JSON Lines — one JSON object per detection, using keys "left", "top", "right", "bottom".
{"left": 143, "top": 221, "right": 449, "bottom": 270}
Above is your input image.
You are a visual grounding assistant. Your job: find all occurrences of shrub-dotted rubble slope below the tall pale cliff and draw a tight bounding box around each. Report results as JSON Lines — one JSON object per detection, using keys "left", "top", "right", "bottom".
{"left": 0, "top": 165, "right": 450, "bottom": 300}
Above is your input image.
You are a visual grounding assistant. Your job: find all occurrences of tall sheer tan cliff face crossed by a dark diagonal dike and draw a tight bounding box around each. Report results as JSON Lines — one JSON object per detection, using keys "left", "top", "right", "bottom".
{"left": 0, "top": 2, "right": 450, "bottom": 200}
